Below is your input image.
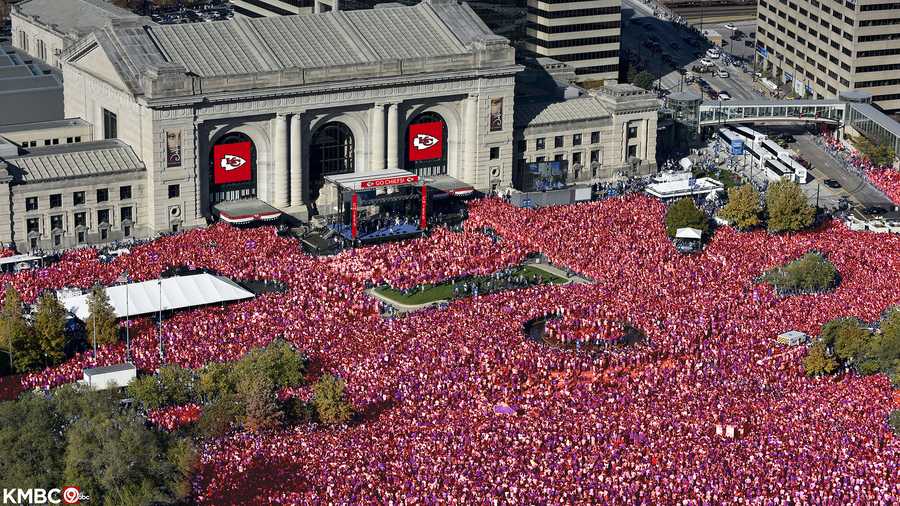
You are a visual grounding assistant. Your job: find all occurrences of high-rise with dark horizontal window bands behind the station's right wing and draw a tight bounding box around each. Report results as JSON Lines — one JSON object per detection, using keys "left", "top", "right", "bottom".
{"left": 525, "top": 0, "right": 622, "bottom": 83}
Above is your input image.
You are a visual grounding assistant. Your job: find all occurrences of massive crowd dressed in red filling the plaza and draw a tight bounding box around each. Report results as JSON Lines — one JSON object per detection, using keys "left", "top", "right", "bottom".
{"left": 1, "top": 196, "right": 900, "bottom": 504}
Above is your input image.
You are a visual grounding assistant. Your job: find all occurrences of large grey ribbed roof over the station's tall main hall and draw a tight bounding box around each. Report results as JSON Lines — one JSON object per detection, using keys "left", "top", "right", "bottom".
{"left": 77, "top": 0, "right": 513, "bottom": 97}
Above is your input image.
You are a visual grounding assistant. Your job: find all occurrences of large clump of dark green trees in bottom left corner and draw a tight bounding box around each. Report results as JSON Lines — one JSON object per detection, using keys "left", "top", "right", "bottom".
{"left": 0, "top": 386, "right": 196, "bottom": 504}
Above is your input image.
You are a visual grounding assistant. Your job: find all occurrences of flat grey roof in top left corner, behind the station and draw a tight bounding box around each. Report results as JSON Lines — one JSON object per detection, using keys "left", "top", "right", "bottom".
{"left": 13, "top": 0, "right": 138, "bottom": 38}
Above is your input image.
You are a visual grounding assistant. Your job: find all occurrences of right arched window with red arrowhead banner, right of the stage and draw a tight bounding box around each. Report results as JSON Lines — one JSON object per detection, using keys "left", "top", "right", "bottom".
{"left": 404, "top": 111, "right": 447, "bottom": 176}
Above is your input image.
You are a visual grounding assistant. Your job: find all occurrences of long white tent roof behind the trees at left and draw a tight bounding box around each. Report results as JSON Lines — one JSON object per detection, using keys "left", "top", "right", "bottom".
{"left": 62, "top": 274, "right": 253, "bottom": 320}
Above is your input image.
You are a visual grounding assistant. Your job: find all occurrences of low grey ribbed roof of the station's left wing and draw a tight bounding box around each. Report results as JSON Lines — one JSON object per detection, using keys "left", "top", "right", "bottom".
{"left": 4, "top": 139, "right": 144, "bottom": 183}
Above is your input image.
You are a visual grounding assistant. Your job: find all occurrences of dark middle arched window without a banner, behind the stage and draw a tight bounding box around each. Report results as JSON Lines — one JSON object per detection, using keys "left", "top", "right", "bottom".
{"left": 309, "top": 121, "right": 356, "bottom": 202}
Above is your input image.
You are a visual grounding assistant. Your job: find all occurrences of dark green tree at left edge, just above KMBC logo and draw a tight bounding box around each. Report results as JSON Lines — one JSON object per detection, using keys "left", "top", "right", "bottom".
{"left": 0, "top": 393, "right": 65, "bottom": 489}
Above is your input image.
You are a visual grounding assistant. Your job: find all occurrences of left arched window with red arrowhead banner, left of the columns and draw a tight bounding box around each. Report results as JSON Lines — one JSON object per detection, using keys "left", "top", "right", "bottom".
{"left": 209, "top": 132, "right": 256, "bottom": 206}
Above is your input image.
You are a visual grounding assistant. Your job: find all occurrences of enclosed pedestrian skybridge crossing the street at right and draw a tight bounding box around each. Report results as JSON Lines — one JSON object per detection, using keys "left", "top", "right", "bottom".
{"left": 698, "top": 100, "right": 850, "bottom": 127}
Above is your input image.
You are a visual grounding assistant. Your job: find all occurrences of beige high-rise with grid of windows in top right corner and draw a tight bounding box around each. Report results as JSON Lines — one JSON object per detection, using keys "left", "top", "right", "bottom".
{"left": 756, "top": 0, "right": 900, "bottom": 112}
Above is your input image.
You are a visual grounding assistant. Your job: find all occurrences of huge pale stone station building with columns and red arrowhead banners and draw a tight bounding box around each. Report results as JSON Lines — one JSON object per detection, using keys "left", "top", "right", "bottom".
{"left": 0, "top": 0, "right": 658, "bottom": 251}
